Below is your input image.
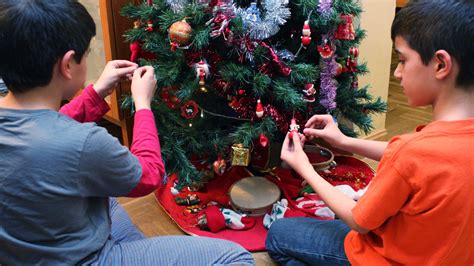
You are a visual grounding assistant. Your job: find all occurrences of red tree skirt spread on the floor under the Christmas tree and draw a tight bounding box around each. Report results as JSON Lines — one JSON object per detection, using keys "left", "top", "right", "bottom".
{"left": 155, "top": 156, "right": 374, "bottom": 251}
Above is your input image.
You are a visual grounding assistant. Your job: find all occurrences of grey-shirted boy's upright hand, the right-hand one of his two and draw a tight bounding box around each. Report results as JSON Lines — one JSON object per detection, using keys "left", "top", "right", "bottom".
{"left": 131, "top": 66, "right": 156, "bottom": 111}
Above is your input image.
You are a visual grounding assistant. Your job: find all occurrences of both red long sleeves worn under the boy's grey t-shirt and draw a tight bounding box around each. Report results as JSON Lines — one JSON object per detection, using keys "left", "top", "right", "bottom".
{"left": 59, "top": 84, "right": 165, "bottom": 197}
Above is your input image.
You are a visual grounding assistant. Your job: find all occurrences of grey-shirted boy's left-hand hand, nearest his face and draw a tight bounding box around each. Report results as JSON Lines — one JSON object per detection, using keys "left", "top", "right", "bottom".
{"left": 94, "top": 60, "right": 138, "bottom": 98}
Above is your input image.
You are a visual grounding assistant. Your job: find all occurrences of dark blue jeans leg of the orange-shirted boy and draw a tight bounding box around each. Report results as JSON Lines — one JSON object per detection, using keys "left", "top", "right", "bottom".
{"left": 265, "top": 217, "right": 350, "bottom": 265}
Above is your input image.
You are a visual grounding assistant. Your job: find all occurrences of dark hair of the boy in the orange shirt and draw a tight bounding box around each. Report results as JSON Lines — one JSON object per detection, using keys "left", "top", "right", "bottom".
{"left": 392, "top": 0, "right": 474, "bottom": 88}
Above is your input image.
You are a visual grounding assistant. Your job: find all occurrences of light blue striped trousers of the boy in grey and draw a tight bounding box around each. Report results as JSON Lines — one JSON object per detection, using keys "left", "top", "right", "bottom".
{"left": 87, "top": 198, "right": 255, "bottom": 266}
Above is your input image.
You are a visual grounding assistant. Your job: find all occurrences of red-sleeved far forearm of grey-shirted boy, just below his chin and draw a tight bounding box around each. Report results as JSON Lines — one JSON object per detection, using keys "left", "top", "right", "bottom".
{"left": 59, "top": 84, "right": 109, "bottom": 123}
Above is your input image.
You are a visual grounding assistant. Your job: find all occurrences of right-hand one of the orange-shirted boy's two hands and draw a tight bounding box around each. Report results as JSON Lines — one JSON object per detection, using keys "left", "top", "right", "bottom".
{"left": 303, "top": 115, "right": 347, "bottom": 148}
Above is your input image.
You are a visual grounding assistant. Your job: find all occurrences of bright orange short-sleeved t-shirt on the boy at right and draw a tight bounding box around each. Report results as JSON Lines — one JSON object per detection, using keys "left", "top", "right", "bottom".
{"left": 344, "top": 119, "right": 474, "bottom": 266}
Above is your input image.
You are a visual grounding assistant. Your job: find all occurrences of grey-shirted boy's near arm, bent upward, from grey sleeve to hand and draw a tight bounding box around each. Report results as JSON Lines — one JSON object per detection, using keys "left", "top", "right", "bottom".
{"left": 79, "top": 66, "right": 165, "bottom": 197}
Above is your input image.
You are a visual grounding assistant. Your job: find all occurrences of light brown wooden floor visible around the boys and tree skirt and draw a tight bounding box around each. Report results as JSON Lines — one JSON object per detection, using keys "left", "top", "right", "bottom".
{"left": 119, "top": 50, "right": 431, "bottom": 265}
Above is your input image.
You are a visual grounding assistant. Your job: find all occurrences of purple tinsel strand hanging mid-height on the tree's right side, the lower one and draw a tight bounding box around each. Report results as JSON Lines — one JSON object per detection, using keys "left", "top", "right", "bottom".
{"left": 319, "top": 56, "right": 337, "bottom": 112}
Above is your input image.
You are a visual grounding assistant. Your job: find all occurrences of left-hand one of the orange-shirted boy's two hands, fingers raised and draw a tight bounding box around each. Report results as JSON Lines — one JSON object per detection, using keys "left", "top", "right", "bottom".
{"left": 280, "top": 134, "right": 312, "bottom": 173}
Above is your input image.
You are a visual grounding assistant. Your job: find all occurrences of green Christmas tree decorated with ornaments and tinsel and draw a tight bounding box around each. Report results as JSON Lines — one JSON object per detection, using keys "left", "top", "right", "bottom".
{"left": 122, "top": 0, "right": 386, "bottom": 191}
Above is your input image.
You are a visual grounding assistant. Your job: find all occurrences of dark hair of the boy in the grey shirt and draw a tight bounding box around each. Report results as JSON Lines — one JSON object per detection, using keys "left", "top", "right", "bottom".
{"left": 0, "top": 0, "right": 95, "bottom": 93}
